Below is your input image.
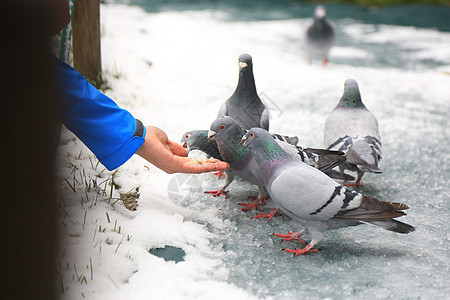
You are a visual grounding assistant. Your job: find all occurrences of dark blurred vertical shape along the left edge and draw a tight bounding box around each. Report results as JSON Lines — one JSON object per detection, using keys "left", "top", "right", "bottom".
{"left": 0, "top": 0, "right": 61, "bottom": 299}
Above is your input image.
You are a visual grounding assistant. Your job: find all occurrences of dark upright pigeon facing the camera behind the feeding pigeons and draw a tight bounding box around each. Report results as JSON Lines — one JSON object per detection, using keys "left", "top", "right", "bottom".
{"left": 217, "top": 54, "right": 269, "bottom": 130}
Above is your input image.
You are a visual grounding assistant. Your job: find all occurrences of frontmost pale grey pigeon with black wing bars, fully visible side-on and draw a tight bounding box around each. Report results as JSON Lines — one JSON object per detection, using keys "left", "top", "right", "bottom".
{"left": 241, "top": 128, "right": 415, "bottom": 255}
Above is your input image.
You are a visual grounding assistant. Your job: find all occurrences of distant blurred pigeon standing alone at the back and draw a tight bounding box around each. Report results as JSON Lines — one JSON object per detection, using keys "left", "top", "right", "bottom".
{"left": 305, "top": 5, "right": 336, "bottom": 65}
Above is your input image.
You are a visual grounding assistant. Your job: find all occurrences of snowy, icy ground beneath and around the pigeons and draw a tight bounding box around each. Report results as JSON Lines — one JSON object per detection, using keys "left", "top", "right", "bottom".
{"left": 57, "top": 4, "right": 450, "bottom": 300}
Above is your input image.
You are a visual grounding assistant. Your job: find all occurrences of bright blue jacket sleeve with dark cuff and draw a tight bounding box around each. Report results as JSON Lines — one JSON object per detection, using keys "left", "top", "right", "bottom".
{"left": 54, "top": 57, "right": 145, "bottom": 170}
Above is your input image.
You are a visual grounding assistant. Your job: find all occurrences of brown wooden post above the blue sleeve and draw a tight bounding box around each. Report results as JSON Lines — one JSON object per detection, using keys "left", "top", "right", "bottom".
{"left": 72, "top": 0, "right": 102, "bottom": 86}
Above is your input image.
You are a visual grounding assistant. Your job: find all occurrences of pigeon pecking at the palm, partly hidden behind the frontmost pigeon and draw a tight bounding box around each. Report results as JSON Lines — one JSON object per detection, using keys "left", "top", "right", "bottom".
{"left": 208, "top": 116, "right": 352, "bottom": 218}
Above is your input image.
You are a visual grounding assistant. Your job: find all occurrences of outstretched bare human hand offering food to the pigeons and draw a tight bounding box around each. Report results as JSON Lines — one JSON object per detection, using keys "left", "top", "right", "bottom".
{"left": 136, "top": 126, "right": 230, "bottom": 174}
